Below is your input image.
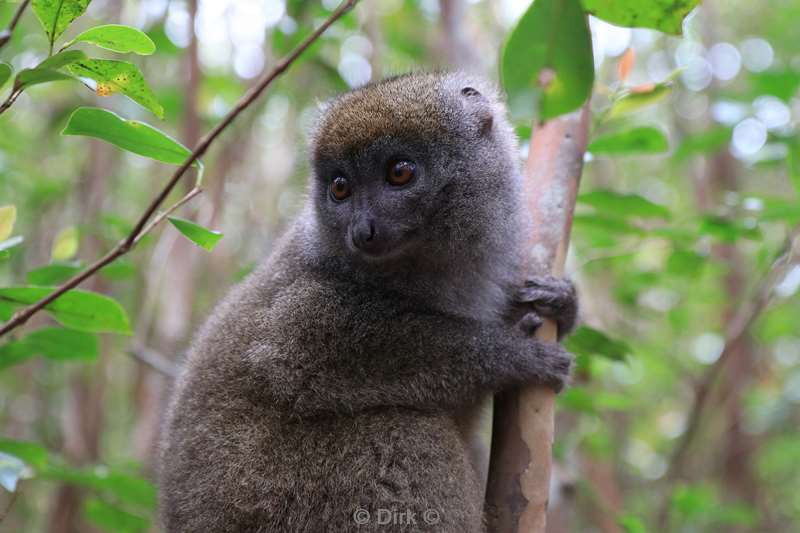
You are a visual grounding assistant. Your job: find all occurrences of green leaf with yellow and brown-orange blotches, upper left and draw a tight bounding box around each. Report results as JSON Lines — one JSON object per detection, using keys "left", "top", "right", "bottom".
{"left": 67, "top": 59, "right": 164, "bottom": 118}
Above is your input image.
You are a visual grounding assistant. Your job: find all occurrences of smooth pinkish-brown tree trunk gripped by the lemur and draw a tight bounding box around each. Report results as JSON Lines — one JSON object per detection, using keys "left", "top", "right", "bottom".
{"left": 487, "top": 105, "right": 589, "bottom": 533}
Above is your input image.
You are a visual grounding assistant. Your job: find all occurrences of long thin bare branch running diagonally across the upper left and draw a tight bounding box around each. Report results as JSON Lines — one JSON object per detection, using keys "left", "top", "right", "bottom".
{"left": 0, "top": 0, "right": 358, "bottom": 337}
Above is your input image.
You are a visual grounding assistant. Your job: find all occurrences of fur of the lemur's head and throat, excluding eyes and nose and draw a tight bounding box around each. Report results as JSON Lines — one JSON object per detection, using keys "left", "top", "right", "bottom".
{"left": 309, "top": 73, "right": 525, "bottom": 318}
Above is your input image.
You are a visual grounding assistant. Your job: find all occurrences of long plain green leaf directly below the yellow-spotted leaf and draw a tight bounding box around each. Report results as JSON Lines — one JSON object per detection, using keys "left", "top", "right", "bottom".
{"left": 61, "top": 107, "right": 196, "bottom": 168}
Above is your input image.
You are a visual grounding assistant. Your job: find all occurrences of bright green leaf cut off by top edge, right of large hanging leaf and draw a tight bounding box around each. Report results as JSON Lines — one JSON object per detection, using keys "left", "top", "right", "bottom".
{"left": 582, "top": 0, "right": 700, "bottom": 35}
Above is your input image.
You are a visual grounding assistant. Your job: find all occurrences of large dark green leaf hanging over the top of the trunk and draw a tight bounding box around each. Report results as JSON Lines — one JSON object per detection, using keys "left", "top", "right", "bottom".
{"left": 501, "top": 0, "right": 594, "bottom": 121}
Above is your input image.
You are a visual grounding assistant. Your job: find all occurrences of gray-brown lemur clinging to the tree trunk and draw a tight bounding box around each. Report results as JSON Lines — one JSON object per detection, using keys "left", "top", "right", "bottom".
{"left": 160, "top": 73, "right": 576, "bottom": 533}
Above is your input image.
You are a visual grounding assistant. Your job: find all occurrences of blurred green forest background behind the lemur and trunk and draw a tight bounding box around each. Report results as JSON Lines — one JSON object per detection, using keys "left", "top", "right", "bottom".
{"left": 0, "top": 0, "right": 800, "bottom": 533}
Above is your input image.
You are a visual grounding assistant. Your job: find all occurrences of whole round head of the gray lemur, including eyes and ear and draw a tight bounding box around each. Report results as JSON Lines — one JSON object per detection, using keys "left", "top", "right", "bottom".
{"left": 310, "top": 73, "right": 521, "bottom": 266}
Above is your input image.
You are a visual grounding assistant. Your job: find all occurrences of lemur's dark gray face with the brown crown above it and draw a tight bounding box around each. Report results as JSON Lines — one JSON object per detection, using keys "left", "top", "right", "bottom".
{"left": 311, "top": 72, "right": 504, "bottom": 263}
